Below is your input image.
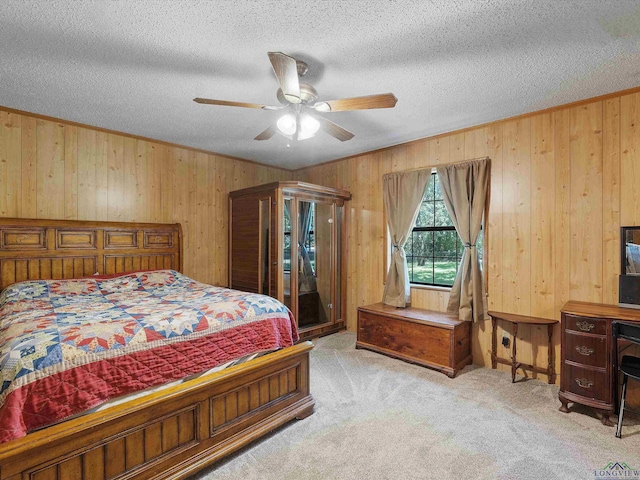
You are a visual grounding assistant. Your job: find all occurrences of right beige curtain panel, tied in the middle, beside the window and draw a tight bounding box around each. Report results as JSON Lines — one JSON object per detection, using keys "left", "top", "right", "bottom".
{"left": 436, "top": 158, "right": 490, "bottom": 321}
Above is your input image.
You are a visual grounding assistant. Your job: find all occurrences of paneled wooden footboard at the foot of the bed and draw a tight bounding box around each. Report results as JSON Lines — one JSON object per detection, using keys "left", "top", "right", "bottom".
{"left": 0, "top": 342, "right": 315, "bottom": 480}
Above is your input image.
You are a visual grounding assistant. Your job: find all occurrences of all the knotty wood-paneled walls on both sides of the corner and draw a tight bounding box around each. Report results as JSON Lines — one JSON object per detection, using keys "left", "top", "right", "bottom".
{"left": 5, "top": 85, "right": 640, "bottom": 386}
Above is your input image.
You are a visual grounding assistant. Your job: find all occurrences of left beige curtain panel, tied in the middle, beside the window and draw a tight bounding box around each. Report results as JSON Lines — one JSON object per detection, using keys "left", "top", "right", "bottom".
{"left": 382, "top": 169, "right": 431, "bottom": 307}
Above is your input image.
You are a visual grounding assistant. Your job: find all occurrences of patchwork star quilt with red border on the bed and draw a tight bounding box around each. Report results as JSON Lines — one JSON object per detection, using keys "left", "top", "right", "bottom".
{"left": 0, "top": 270, "right": 298, "bottom": 443}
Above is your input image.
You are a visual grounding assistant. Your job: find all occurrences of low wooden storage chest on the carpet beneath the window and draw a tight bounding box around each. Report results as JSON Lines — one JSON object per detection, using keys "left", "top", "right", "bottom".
{"left": 356, "top": 303, "right": 472, "bottom": 378}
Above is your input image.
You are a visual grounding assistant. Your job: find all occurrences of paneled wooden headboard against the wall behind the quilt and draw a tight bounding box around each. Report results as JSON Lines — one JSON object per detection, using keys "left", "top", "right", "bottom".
{"left": 0, "top": 218, "right": 182, "bottom": 290}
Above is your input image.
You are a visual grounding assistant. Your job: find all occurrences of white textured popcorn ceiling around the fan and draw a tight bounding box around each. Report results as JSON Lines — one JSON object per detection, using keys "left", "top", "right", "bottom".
{"left": 0, "top": 0, "right": 640, "bottom": 168}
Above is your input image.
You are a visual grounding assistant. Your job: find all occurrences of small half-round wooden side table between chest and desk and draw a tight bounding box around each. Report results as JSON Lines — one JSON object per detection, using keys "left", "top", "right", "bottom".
{"left": 489, "top": 312, "right": 558, "bottom": 384}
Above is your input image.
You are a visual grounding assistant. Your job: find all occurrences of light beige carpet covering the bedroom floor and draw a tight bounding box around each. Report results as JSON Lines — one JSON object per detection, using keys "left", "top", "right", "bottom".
{"left": 194, "top": 333, "right": 640, "bottom": 480}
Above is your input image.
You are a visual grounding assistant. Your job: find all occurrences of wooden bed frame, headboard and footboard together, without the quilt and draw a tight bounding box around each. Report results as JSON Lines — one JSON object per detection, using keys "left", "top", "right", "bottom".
{"left": 0, "top": 219, "right": 314, "bottom": 480}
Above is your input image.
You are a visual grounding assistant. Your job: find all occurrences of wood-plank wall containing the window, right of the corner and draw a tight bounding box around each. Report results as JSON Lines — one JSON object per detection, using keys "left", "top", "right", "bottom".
{"left": 295, "top": 92, "right": 640, "bottom": 386}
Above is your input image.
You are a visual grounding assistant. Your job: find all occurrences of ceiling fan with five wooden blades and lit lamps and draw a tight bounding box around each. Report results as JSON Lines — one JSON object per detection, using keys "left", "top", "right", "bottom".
{"left": 193, "top": 52, "right": 398, "bottom": 142}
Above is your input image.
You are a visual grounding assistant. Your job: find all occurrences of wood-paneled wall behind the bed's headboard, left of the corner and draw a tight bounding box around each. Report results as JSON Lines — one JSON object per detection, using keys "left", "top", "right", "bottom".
{"left": 0, "top": 109, "right": 292, "bottom": 285}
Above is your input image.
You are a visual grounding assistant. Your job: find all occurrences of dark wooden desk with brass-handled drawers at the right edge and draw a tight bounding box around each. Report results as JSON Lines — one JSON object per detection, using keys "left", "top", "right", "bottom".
{"left": 558, "top": 301, "right": 640, "bottom": 425}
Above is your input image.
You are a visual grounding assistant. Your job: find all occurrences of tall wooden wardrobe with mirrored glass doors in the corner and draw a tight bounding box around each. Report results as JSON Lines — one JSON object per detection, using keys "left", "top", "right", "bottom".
{"left": 229, "top": 181, "right": 351, "bottom": 339}
